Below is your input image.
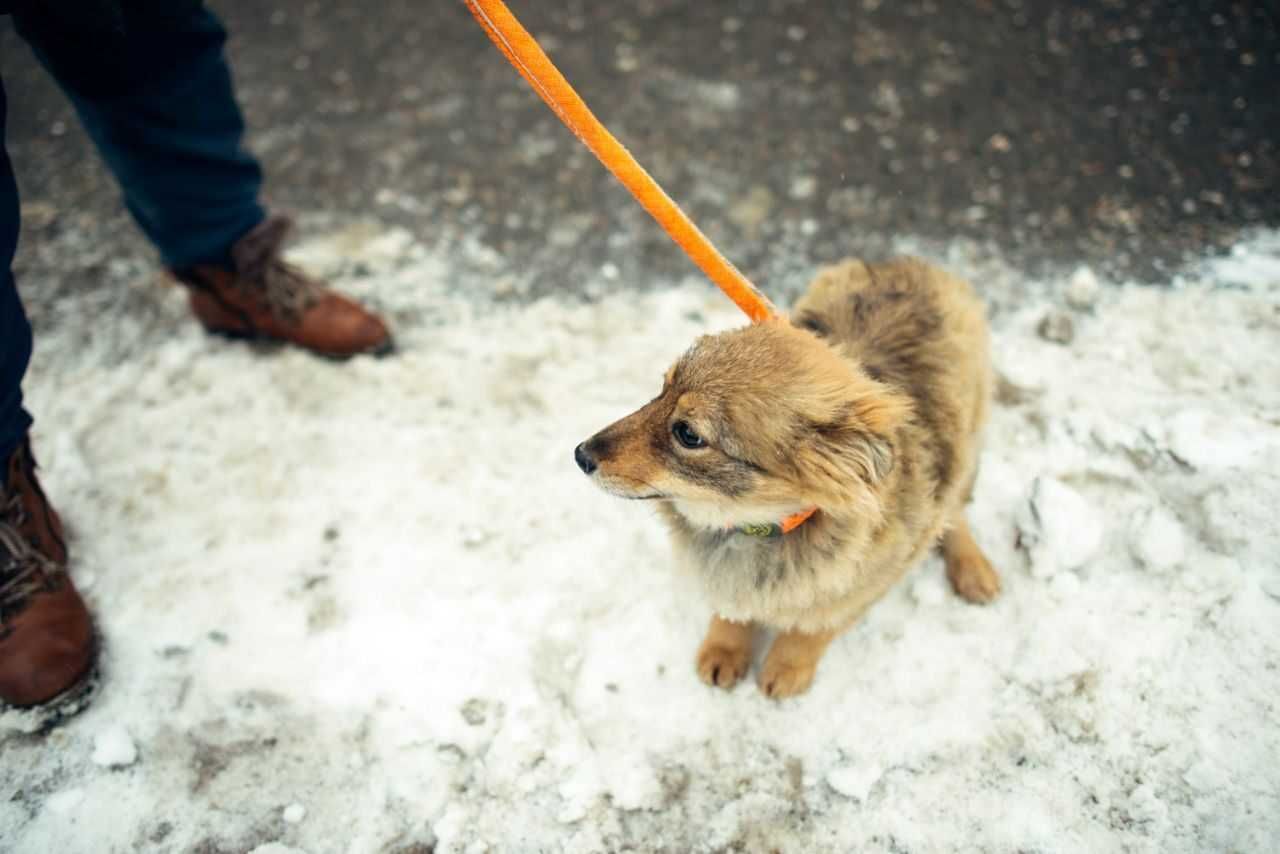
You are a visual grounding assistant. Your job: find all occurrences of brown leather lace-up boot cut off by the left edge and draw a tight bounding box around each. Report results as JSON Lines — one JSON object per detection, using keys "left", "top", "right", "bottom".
{"left": 0, "top": 439, "right": 97, "bottom": 707}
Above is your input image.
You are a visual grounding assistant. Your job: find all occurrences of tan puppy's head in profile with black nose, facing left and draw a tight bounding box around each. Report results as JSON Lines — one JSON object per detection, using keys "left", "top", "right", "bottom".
{"left": 573, "top": 320, "right": 909, "bottom": 528}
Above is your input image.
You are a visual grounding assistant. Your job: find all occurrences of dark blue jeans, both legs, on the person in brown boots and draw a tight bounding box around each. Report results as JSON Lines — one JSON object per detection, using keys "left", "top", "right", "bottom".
{"left": 0, "top": 0, "right": 265, "bottom": 463}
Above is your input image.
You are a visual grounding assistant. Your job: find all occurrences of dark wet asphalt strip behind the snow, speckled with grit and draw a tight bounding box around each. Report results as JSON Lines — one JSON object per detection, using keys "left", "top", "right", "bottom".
{"left": 0, "top": 0, "right": 1280, "bottom": 297}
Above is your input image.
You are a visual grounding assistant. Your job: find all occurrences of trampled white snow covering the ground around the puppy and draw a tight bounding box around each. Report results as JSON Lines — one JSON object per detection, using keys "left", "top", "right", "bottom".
{"left": 0, "top": 225, "right": 1280, "bottom": 854}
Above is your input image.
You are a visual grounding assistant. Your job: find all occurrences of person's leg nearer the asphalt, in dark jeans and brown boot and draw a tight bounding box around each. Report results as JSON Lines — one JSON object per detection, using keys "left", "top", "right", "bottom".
{"left": 17, "top": 0, "right": 392, "bottom": 357}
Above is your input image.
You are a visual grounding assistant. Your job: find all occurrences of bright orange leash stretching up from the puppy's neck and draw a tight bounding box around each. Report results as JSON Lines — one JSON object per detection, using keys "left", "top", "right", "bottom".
{"left": 465, "top": 0, "right": 778, "bottom": 323}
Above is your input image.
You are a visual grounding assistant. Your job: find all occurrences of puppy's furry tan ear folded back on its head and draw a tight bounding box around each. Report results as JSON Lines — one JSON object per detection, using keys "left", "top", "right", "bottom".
{"left": 792, "top": 379, "right": 911, "bottom": 501}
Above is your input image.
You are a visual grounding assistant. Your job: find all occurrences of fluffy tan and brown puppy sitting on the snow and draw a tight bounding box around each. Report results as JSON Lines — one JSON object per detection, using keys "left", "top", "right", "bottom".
{"left": 573, "top": 260, "right": 1000, "bottom": 698}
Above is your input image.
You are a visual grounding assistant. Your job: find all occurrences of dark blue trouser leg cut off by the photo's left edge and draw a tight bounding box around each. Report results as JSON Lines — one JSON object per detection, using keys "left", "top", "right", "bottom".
{"left": 0, "top": 82, "right": 31, "bottom": 461}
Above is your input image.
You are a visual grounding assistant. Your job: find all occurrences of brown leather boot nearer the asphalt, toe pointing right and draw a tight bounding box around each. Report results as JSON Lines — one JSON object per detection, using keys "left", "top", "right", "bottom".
{"left": 172, "top": 215, "right": 392, "bottom": 359}
